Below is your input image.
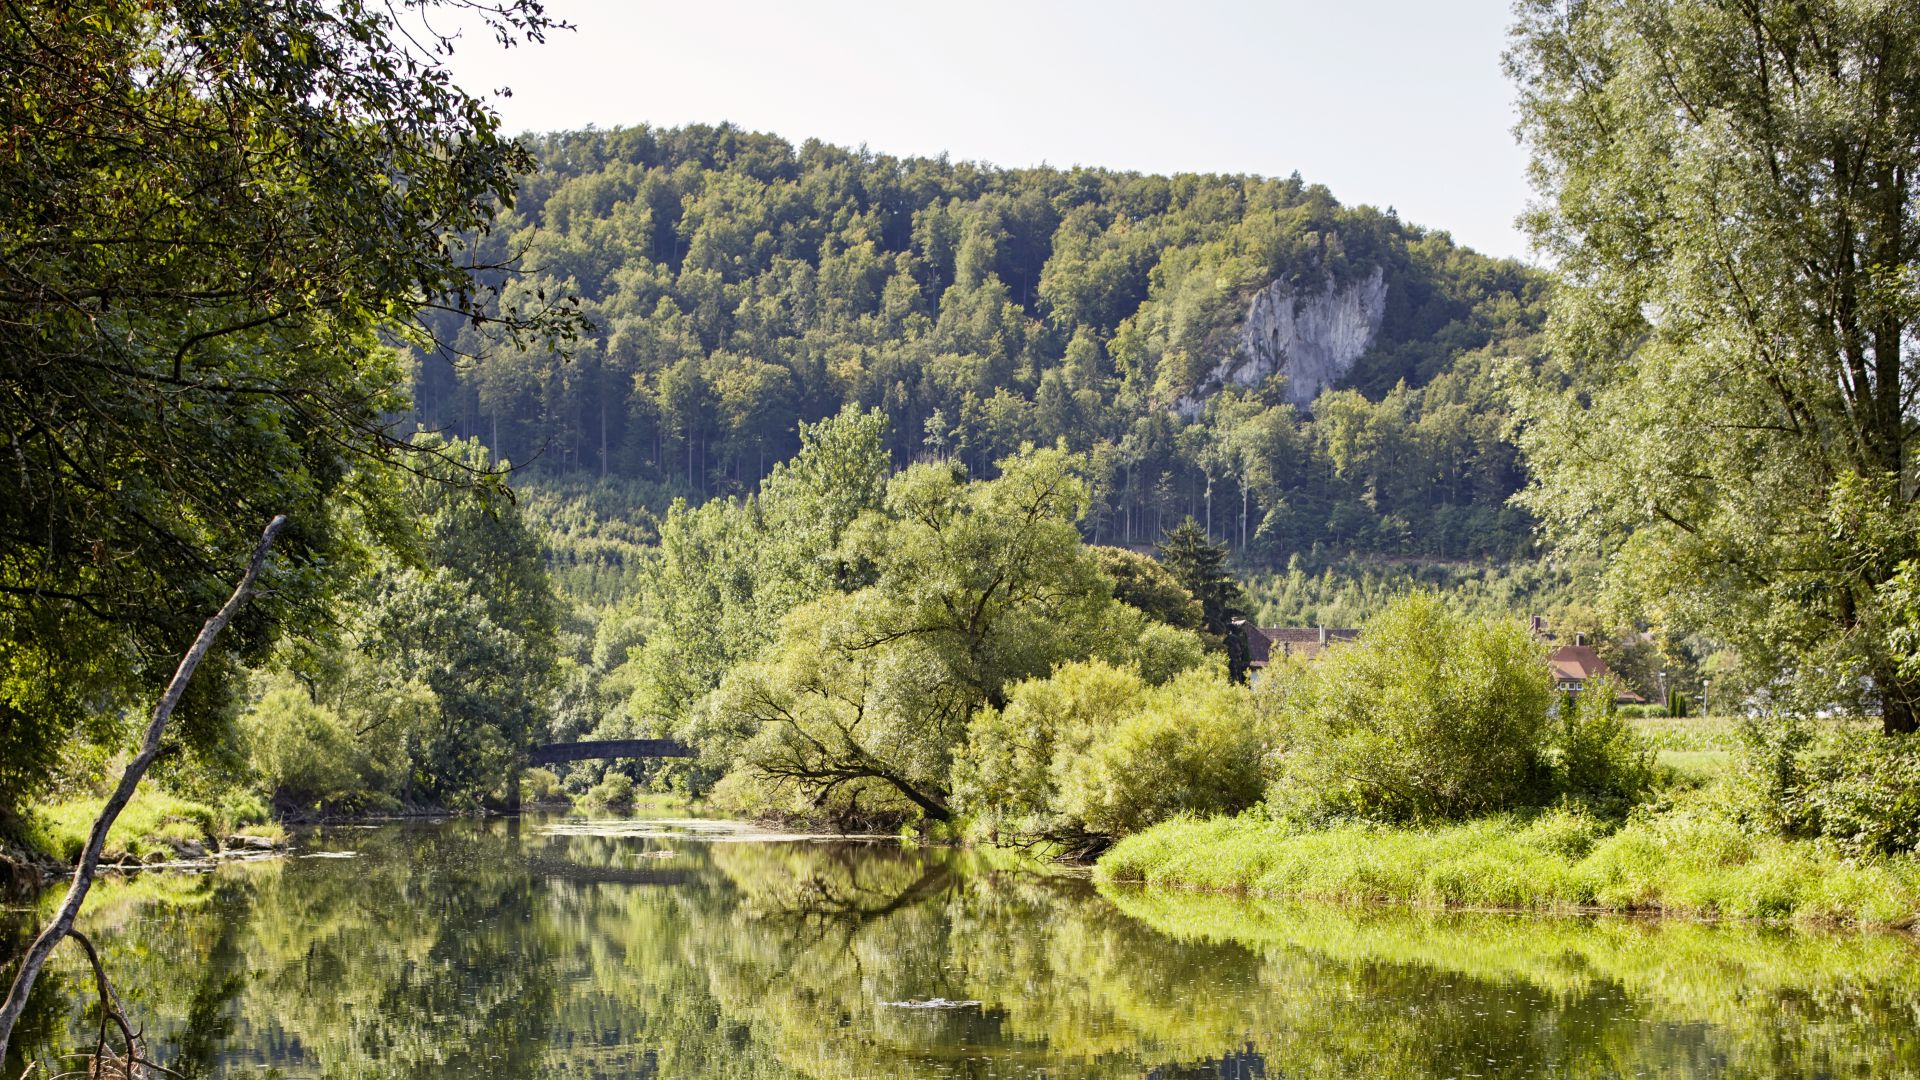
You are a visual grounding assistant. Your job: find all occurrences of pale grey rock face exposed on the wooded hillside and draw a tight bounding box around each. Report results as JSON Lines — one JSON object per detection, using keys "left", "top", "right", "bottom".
{"left": 1175, "top": 267, "right": 1386, "bottom": 411}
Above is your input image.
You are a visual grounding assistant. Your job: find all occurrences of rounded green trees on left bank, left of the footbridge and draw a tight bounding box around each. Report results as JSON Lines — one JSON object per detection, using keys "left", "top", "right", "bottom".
{"left": 242, "top": 434, "right": 559, "bottom": 809}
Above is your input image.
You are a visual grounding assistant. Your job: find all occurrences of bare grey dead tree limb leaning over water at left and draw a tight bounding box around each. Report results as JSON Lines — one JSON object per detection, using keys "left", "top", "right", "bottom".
{"left": 0, "top": 515, "right": 286, "bottom": 1061}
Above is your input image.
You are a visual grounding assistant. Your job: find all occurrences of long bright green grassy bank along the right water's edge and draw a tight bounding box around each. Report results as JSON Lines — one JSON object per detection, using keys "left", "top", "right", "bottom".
{"left": 1094, "top": 798, "right": 1920, "bottom": 926}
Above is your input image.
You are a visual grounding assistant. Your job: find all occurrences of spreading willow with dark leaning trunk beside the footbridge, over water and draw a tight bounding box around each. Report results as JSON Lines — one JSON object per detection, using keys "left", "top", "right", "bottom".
{"left": 705, "top": 448, "right": 1198, "bottom": 821}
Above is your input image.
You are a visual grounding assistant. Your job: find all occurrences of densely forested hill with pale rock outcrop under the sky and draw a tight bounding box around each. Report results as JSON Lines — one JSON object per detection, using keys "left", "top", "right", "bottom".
{"left": 415, "top": 125, "right": 1544, "bottom": 563}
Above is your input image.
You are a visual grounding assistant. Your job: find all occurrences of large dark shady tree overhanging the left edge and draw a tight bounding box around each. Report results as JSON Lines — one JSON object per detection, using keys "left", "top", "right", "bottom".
{"left": 0, "top": 0, "right": 578, "bottom": 811}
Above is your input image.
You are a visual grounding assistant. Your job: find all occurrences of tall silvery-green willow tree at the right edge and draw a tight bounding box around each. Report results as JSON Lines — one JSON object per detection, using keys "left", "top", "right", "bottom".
{"left": 1507, "top": 0, "right": 1920, "bottom": 732}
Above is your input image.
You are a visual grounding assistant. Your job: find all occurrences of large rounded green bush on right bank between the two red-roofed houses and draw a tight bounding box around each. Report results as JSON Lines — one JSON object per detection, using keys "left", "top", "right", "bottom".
{"left": 1256, "top": 592, "right": 1559, "bottom": 821}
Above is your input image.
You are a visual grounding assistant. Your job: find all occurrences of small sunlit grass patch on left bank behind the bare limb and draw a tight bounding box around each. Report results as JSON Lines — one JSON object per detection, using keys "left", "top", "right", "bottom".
{"left": 25, "top": 786, "right": 284, "bottom": 863}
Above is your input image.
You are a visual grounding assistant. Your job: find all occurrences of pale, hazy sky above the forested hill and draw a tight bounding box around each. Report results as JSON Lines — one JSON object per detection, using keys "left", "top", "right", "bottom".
{"left": 441, "top": 0, "right": 1528, "bottom": 258}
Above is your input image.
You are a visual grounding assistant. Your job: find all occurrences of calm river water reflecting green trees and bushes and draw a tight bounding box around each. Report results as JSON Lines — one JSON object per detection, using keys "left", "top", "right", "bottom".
{"left": 0, "top": 817, "right": 1920, "bottom": 1080}
